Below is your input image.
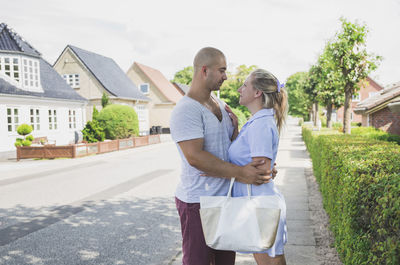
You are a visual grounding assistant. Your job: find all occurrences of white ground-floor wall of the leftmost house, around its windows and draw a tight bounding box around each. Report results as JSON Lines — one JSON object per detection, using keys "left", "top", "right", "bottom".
{"left": 0, "top": 95, "right": 86, "bottom": 152}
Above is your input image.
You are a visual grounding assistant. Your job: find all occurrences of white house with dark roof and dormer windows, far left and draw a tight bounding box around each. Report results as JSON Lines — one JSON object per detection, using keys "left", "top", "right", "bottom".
{"left": 0, "top": 23, "right": 87, "bottom": 152}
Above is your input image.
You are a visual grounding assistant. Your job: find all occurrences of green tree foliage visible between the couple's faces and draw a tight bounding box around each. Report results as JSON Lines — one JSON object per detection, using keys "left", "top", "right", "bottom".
{"left": 220, "top": 64, "right": 257, "bottom": 118}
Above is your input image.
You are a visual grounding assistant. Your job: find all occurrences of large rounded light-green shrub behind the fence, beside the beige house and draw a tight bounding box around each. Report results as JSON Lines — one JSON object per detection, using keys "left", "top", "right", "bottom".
{"left": 97, "top": 104, "right": 139, "bottom": 140}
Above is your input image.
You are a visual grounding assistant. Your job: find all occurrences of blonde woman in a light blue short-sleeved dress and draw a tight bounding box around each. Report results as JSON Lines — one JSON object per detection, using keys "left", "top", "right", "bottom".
{"left": 228, "top": 69, "right": 288, "bottom": 265}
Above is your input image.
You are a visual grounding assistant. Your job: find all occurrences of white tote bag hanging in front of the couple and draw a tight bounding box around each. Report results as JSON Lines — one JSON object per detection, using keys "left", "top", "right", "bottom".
{"left": 200, "top": 178, "right": 281, "bottom": 252}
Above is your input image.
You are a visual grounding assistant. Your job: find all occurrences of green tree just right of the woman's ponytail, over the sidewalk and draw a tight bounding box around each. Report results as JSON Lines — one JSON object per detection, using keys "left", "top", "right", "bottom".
{"left": 285, "top": 72, "right": 312, "bottom": 121}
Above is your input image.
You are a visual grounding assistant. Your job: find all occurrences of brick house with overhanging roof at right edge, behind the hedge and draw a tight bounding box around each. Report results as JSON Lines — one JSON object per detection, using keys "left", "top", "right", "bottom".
{"left": 354, "top": 82, "right": 400, "bottom": 135}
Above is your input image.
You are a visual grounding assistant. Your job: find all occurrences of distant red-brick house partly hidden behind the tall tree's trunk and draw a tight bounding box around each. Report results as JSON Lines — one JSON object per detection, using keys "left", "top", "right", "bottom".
{"left": 336, "top": 77, "right": 383, "bottom": 123}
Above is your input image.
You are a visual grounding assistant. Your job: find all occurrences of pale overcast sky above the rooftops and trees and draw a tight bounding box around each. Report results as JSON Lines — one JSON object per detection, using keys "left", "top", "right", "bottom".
{"left": 0, "top": 0, "right": 400, "bottom": 85}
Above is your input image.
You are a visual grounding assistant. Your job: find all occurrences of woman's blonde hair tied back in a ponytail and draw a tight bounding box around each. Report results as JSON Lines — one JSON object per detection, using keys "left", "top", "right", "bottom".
{"left": 250, "top": 69, "right": 289, "bottom": 134}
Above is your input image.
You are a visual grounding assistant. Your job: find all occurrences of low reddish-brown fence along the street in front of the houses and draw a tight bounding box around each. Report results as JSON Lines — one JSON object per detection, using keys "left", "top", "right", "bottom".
{"left": 17, "top": 134, "right": 161, "bottom": 161}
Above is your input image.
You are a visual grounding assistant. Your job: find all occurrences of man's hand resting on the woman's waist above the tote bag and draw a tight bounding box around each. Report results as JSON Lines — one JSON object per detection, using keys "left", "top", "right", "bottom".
{"left": 236, "top": 159, "right": 272, "bottom": 185}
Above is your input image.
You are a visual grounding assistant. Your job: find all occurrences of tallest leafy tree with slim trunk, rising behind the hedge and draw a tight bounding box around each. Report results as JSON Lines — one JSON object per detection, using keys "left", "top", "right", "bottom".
{"left": 331, "top": 18, "right": 382, "bottom": 134}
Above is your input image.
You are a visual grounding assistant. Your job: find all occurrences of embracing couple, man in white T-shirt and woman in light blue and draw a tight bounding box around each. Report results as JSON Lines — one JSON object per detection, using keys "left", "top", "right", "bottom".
{"left": 170, "top": 47, "right": 288, "bottom": 265}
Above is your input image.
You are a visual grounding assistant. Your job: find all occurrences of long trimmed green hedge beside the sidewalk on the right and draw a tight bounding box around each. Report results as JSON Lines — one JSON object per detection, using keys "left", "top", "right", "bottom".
{"left": 303, "top": 127, "right": 400, "bottom": 265}
